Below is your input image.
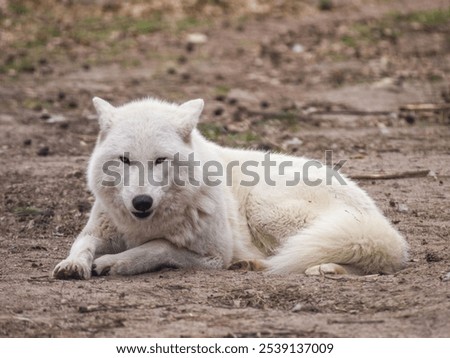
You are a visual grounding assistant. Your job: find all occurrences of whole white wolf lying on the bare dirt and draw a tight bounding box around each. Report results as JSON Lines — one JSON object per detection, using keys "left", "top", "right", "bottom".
{"left": 53, "top": 98, "right": 407, "bottom": 279}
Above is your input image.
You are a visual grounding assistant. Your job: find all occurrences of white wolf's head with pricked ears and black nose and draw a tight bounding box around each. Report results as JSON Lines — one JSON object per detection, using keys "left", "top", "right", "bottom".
{"left": 88, "top": 97, "right": 203, "bottom": 228}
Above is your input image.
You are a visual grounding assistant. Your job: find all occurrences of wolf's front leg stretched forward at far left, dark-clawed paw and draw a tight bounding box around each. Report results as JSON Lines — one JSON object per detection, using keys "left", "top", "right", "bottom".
{"left": 53, "top": 233, "right": 103, "bottom": 280}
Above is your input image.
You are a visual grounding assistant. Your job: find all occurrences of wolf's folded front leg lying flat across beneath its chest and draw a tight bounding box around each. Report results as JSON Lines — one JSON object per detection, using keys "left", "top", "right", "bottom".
{"left": 92, "top": 240, "right": 224, "bottom": 275}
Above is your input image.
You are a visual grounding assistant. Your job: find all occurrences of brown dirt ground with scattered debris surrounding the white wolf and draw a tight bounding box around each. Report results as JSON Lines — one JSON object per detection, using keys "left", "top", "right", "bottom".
{"left": 0, "top": 0, "right": 450, "bottom": 337}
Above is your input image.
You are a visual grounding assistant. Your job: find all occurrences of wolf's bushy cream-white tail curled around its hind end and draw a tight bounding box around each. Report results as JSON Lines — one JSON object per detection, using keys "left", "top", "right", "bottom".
{"left": 266, "top": 208, "right": 408, "bottom": 274}
